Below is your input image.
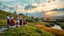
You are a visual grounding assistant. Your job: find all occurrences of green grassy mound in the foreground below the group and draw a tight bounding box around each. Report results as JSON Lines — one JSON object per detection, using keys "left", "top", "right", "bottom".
{"left": 3, "top": 25, "right": 54, "bottom": 36}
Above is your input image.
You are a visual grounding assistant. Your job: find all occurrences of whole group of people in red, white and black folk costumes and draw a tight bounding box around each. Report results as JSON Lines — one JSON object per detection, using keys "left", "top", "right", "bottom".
{"left": 7, "top": 15, "right": 27, "bottom": 28}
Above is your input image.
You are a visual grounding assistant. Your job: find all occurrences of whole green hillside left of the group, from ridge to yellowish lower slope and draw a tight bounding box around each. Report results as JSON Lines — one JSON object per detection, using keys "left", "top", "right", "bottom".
{"left": 0, "top": 10, "right": 17, "bottom": 27}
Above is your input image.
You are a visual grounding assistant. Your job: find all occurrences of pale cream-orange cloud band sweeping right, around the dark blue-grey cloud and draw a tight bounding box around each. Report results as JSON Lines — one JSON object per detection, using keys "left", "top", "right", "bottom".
{"left": 16, "top": 0, "right": 64, "bottom": 13}
